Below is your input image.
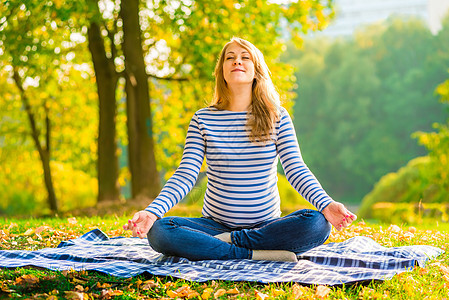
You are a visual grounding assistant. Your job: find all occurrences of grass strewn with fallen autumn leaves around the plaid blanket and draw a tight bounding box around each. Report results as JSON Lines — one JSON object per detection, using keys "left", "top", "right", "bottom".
{"left": 0, "top": 208, "right": 449, "bottom": 300}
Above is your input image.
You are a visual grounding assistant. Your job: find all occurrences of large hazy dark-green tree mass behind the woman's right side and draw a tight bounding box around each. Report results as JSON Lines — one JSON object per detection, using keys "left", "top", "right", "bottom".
{"left": 283, "top": 19, "right": 449, "bottom": 202}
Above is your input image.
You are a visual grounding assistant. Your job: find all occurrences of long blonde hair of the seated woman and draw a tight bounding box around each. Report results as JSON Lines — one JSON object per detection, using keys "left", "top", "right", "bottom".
{"left": 211, "top": 37, "right": 280, "bottom": 142}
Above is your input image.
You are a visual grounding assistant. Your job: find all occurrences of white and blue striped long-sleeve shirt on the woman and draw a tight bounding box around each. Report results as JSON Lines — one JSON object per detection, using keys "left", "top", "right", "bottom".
{"left": 146, "top": 107, "right": 333, "bottom": 227}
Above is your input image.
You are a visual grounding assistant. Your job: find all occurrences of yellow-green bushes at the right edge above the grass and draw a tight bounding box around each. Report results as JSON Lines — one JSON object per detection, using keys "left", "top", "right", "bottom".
{"left": 359, "top": 42, "right": 449, "bottom": 221}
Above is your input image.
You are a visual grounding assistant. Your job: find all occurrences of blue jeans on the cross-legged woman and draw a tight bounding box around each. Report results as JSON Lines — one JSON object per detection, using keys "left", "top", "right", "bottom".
{"left": 148, "top": 209, "right": 331, "bottom": 260}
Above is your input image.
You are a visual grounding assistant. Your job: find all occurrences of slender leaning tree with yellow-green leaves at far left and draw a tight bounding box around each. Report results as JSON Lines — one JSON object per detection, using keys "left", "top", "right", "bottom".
{"left": 0, "top": 2, "right": 98, "bottom": 212}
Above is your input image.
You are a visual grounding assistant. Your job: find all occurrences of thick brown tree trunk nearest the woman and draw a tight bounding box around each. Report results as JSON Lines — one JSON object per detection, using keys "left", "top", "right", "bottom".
{"left": 120, "top": 0, "right": 160, "bottom": 199}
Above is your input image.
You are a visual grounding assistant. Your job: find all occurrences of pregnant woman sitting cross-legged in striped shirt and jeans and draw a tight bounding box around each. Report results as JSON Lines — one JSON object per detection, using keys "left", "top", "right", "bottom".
{"left": 123, "top": 38, "right": 356, "bottom": 261}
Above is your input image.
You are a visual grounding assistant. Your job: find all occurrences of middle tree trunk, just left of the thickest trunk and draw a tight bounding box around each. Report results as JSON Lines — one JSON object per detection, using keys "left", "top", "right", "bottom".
{"left": 88, "top": 23, "right": 120, "bottom": 202}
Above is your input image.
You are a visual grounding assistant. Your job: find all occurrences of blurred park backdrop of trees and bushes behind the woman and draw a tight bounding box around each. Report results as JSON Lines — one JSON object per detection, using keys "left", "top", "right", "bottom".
{"left": 0, "top": 0, "right": 449, "bottom": 222}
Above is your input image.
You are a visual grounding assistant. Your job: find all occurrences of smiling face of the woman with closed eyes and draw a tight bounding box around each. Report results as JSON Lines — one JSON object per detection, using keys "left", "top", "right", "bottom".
{"left": 223, "top": 43, "right": 254, "bottom": 85}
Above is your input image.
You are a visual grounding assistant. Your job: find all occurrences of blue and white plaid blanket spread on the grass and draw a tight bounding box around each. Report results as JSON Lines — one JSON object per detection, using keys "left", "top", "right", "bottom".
{"left": 0, "top": 229, "right": 443, "bottom": 285}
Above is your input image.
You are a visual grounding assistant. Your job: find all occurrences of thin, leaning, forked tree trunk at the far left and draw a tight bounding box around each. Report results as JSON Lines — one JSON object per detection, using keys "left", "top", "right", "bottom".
{"left": 13, "top": 69, "right": 58, "bottom": 213}
